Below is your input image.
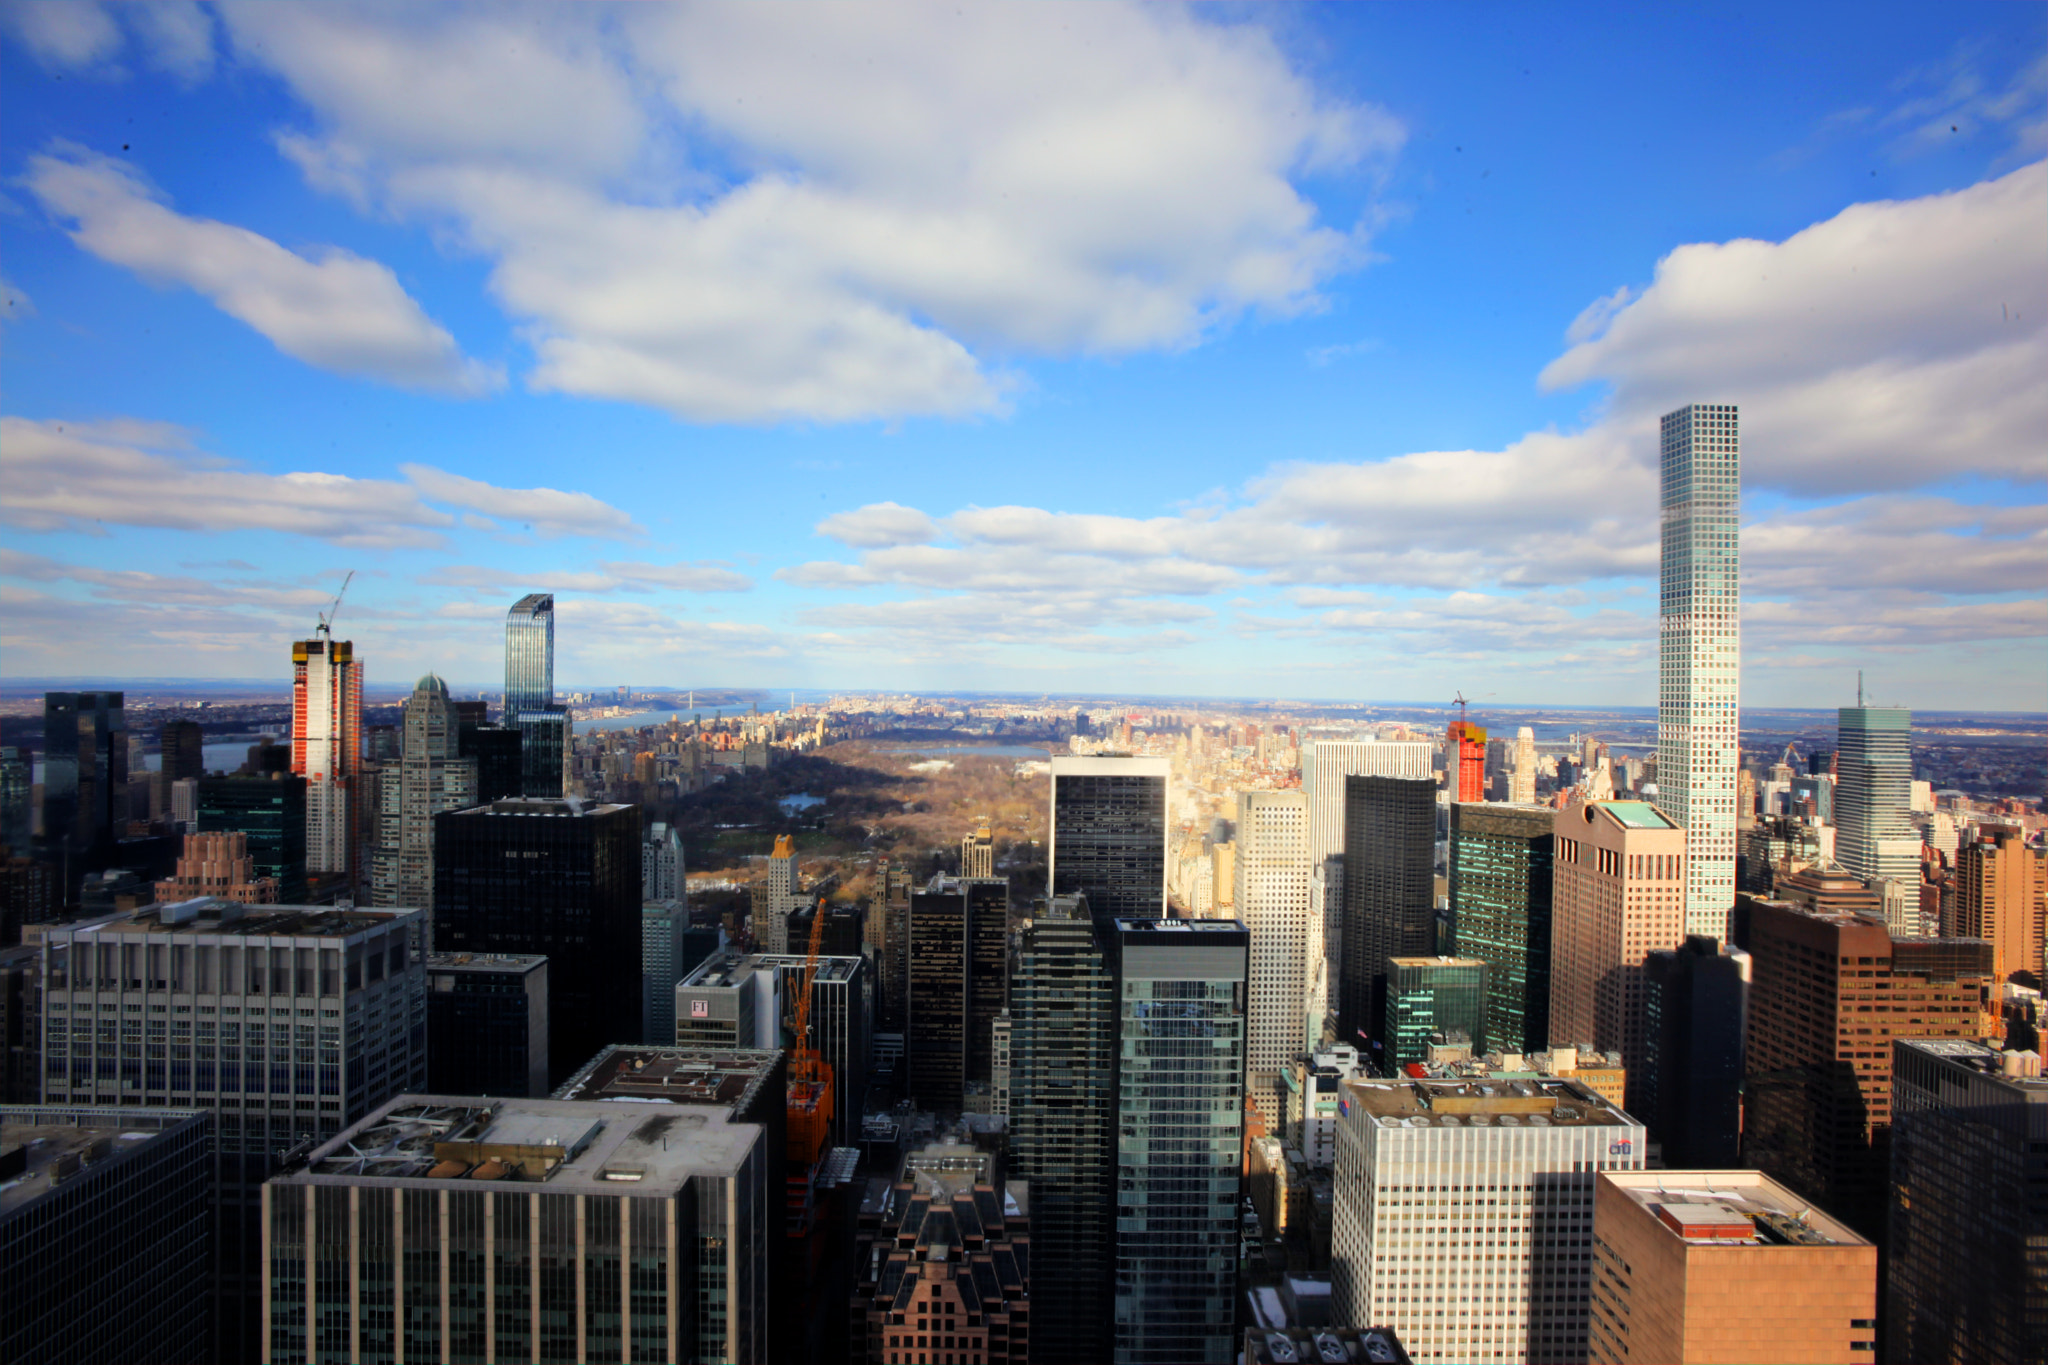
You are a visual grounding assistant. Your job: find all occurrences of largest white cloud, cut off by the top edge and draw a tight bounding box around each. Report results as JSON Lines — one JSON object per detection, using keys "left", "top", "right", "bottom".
{"left": 223, "top": 4, "right": 1403, "bottom": 422}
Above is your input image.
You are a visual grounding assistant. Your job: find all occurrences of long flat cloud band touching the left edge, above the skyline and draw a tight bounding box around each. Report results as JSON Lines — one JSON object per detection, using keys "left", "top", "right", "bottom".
{"left": 0, "top": 417, "right": 637, "bottom": 546}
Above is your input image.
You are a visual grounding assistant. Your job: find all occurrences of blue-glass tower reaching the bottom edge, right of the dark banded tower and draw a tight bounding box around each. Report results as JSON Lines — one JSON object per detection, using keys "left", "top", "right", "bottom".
{"left": 1112, "top": 919, "right": 1251, "bottom": 1365}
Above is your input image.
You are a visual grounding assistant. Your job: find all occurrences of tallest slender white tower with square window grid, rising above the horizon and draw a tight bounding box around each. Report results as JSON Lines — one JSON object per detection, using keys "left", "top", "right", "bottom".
{"left": 1657, "top": 403, "right": 1743, "bottom": 948}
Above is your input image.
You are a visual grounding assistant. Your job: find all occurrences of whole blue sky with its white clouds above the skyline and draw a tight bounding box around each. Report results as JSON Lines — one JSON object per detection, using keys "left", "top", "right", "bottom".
{"left": 0, "top": 10, "right": 2048, "bottom": 710}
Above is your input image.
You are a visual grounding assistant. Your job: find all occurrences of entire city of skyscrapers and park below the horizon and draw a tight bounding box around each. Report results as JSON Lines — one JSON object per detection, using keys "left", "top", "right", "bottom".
{"left": 0, "top": 405, "right": 2048, "bottom": 1365}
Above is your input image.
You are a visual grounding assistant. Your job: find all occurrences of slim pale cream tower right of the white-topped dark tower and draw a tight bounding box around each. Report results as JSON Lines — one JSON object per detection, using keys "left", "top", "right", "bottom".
{"left": 1235, "top": 792, "right": 1323, "bottom": 1132}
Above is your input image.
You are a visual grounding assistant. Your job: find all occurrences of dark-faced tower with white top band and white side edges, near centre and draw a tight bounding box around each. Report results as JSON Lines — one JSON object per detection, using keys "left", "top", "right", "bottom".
{"left": 1047, "top": 753, "right": 1169, "bottom": 919}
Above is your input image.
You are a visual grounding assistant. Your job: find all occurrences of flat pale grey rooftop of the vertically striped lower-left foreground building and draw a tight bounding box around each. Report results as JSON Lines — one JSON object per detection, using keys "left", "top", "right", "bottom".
{"left": 284, "top": 1095, "right": 762, "bottom": 1195}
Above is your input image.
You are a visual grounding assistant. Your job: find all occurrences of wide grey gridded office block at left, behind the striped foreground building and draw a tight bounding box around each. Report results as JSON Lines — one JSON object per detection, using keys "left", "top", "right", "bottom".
{"left": 43, "top": 898, "right": 426, "bottom": 1361}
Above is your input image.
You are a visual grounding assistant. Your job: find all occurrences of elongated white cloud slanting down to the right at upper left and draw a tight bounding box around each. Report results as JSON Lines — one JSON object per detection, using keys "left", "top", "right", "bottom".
{"left": 27, "top": 147, "right": 502, "bottom": 395}
